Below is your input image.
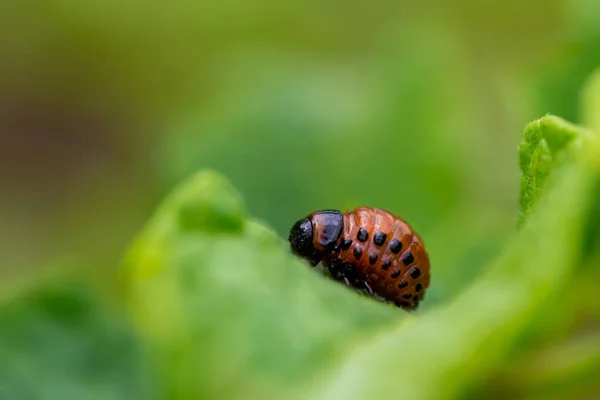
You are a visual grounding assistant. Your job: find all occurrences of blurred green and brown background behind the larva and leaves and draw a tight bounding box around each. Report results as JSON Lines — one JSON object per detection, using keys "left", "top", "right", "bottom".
{"left": 0, "top": 0, "right": 600, "bottom": 298}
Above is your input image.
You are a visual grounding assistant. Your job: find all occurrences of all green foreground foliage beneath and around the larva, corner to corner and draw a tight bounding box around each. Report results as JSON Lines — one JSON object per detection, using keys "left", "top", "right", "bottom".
{"left": 0, "top": 84, "right": 600, "bottom": 399}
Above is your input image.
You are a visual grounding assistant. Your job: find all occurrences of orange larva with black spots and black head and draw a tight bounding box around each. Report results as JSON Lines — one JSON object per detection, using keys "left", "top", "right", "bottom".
{"left": 290, "top": 207, "right": 430, "bottom": 309}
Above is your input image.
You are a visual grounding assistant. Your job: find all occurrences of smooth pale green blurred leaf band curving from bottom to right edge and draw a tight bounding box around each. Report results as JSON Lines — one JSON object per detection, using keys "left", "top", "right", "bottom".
{"left": 311, "top": 126, "right": 600, "bottom": 399}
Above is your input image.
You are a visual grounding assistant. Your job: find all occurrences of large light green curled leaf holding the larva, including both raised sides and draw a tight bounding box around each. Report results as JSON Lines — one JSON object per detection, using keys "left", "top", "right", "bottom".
{"left": 123, "top": 129, "right": 600, "bottom": 399}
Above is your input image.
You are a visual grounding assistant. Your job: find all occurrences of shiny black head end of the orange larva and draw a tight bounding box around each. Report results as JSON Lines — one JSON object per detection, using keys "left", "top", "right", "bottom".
{"left": 288, "top": 210, "right": 344, "bottom": 265}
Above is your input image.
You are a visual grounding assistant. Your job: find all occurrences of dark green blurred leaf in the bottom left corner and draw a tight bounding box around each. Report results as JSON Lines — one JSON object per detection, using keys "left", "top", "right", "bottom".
{"left": 0, "top": 282, "right": 161, "bottom": 400}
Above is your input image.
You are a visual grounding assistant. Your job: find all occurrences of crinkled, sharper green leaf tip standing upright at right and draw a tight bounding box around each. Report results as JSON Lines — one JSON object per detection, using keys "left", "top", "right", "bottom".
{"left": 519, "top": 115, "right": 590, "bottom": 225}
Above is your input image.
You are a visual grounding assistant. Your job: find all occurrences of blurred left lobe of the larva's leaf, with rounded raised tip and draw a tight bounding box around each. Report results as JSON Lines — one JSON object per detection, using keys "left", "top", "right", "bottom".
{"left": 123, "top": 172, "right": 408, "bottom": 399}
